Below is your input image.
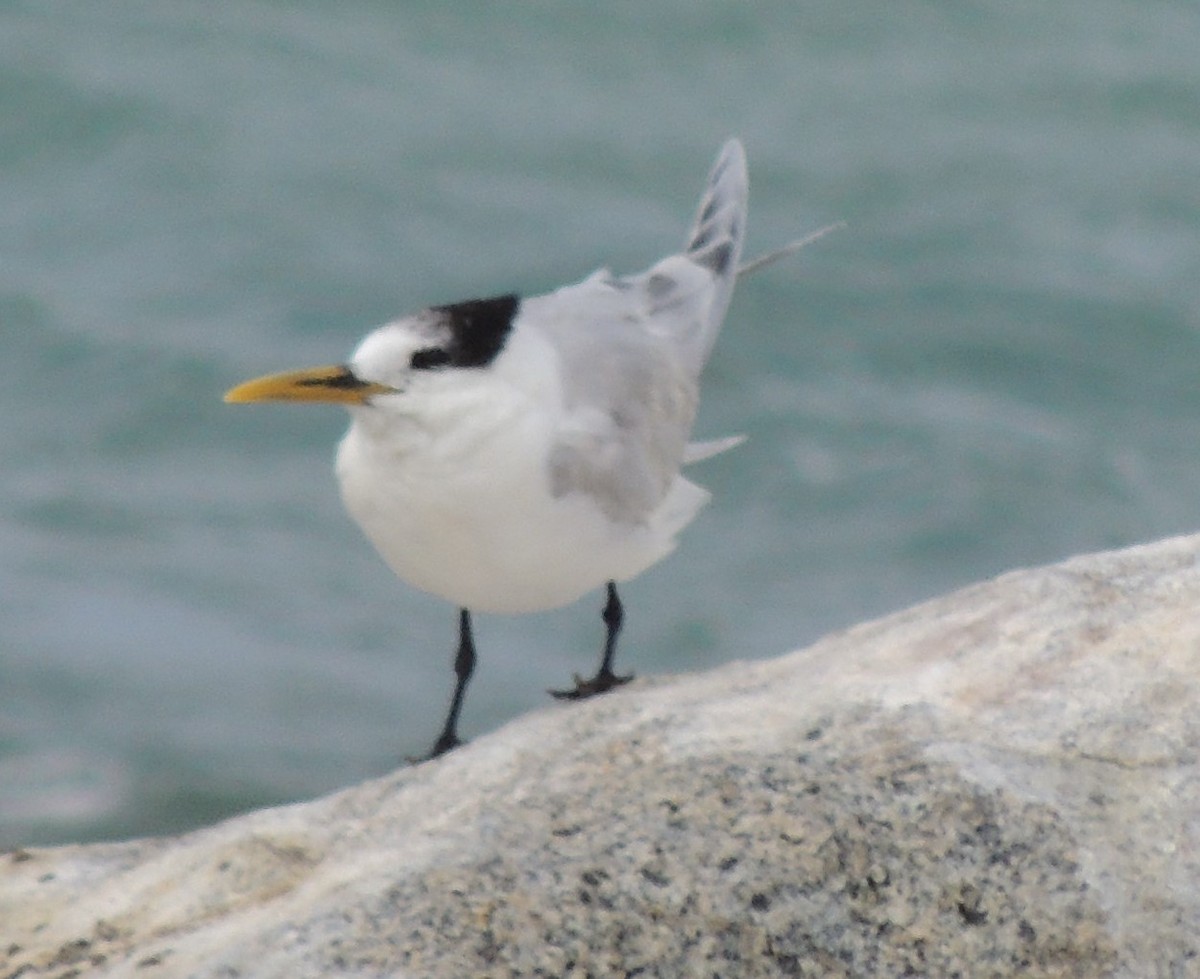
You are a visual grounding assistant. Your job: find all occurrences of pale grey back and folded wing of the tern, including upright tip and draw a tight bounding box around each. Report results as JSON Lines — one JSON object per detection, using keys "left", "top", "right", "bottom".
{"left": 521, "top": 139, "right": 746, "bottom": 523}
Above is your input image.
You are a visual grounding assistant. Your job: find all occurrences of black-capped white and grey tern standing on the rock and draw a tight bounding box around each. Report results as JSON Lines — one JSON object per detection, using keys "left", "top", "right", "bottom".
{"left": 224, "top": 138, "right": 833, "bottom": 758}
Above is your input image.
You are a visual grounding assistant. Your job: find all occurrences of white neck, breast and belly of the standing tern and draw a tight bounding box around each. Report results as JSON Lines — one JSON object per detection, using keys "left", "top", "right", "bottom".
{"left": 337, "top": 314, "right": 708, "bottom": 613}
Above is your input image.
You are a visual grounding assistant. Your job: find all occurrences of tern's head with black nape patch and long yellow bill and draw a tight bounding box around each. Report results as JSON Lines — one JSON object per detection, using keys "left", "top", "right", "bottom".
{"left": 224, "top": 295, "right": 521, "bottom": 407}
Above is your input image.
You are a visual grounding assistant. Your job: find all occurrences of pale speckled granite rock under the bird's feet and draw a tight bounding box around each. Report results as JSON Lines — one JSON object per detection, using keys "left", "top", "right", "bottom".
{"left": 0, "top": 537, "right": 1200, "bottom": 979}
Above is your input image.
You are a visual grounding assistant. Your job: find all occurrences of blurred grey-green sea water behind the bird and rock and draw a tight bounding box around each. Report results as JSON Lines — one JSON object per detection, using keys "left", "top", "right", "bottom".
{"left": 0, "top": 0, "right": 1200, "bottom": 846}
